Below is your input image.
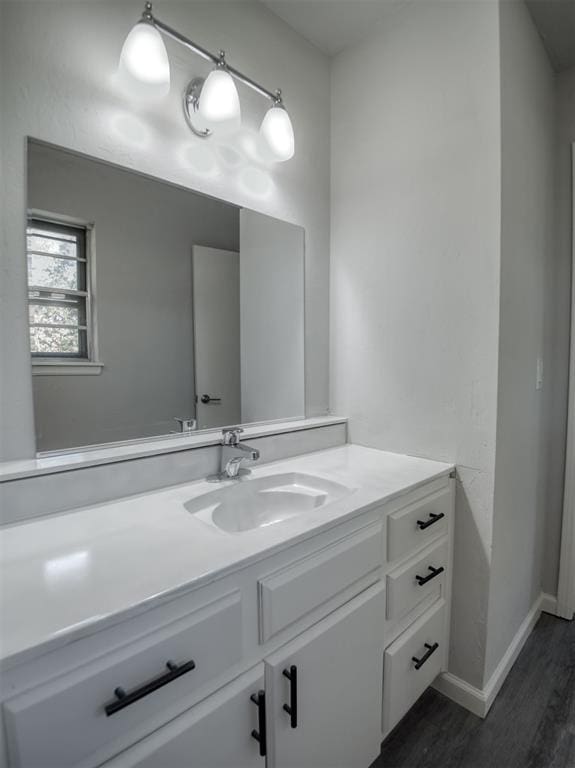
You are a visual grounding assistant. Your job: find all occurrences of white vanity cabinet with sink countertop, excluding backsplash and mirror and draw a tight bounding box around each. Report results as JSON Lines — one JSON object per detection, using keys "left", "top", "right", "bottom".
{"left": 0, "top": 445, "right": 455, "bottom": 768}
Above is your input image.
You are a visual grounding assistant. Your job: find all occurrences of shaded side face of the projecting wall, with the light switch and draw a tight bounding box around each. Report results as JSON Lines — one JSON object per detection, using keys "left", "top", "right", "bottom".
{"left": 485, "top": 0, "right": 565, "bottom": 681}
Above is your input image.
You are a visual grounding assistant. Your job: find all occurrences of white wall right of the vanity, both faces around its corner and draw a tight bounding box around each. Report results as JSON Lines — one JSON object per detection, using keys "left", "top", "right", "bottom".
{"left": 331, "top": 1, "right": 575, "bottom": 688}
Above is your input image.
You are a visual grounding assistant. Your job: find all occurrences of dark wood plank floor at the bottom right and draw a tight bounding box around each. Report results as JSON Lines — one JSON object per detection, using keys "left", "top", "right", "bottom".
{"left": 372, "top": 614, "right": 575, "bottom": 768}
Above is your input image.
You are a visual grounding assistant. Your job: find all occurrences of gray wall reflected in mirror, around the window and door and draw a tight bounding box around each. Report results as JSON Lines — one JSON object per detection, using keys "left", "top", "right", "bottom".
{"left": 28, "top": 143, "right": 239, "bottom": 450}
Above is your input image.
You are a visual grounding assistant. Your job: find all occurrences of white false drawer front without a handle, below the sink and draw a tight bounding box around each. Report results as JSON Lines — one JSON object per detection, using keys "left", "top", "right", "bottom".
{"left": 259, "top": 521, "right": 382, "bottom": 642}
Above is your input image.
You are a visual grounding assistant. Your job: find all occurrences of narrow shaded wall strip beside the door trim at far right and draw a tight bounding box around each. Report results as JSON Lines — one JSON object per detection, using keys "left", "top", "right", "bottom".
{"left": 543, "top": 68, "right": 575, "bottom": 595}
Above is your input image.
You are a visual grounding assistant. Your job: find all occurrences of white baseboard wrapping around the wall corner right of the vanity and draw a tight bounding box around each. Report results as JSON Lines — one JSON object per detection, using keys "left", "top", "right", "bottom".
{"left": 434, "top": 592, "right": 557, "bottom": 717}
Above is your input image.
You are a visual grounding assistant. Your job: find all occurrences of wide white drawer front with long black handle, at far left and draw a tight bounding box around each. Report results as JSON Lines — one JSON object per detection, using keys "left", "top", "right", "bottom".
{"left": 4, "top": 592, "right": 242, "bottom": 768}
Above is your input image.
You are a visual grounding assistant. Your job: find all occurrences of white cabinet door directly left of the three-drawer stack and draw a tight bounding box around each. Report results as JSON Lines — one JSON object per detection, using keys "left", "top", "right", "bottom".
{"left": 266, "top": 583, "right": 385, "bottom": 768}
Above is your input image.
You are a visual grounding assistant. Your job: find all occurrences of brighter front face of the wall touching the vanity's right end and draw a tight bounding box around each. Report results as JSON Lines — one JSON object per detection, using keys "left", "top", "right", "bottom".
{"left": 331, "top": 2, "right": 500, "bottom": 685}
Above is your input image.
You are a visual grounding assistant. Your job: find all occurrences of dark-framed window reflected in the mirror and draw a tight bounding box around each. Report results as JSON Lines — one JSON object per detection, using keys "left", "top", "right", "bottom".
{"left": 26, "top": 218, "right": 92, "bottom": 363}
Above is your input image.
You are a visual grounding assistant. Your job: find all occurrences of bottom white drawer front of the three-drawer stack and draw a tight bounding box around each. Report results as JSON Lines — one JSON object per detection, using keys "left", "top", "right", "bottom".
{"left": 383, "top": 600, "right": 445, "bottom": 735}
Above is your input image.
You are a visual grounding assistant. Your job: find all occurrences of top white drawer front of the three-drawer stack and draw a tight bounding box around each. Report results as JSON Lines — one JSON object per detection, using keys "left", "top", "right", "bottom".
{"left": 387, "top": 490, "right": 451, "bottom": 562}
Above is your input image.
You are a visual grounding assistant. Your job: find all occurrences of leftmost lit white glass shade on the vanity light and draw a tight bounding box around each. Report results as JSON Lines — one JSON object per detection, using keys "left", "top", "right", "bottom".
{"left": 120, "top": 21, "right": 170, "bottom": 94}
